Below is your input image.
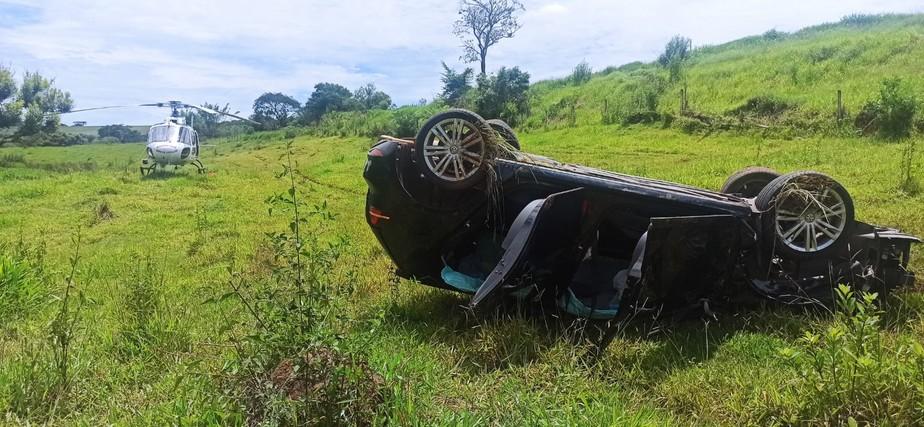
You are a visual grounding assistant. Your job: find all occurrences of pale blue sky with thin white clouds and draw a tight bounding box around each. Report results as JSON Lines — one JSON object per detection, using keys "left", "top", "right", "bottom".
{"left": 0, "top": 0, "right": 924, "bottom": 125}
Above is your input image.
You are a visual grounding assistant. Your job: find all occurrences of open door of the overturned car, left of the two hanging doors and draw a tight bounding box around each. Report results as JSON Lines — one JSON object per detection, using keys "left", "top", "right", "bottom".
{"left": 470, "top": 188, "right": 583, "bottom": 310}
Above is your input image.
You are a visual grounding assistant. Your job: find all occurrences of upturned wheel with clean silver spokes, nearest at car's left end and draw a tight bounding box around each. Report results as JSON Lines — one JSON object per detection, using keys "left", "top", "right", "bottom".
{"left": 415, "top": 109, "right": 494, "bottom": 190}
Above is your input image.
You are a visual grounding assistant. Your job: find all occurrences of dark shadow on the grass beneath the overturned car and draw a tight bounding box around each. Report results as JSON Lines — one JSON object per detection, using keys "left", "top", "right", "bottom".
{"left": 385, "top": 284, "right": 821, "bottom": 376}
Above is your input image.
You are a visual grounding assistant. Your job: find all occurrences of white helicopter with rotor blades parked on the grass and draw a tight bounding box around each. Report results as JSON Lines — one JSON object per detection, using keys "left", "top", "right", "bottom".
{"left": 68, "top": 101, "right": 259, "bottom": 175}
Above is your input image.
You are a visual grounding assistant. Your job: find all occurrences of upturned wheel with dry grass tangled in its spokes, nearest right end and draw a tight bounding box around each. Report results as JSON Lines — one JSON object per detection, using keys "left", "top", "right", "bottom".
{"left": 754, "top": 171, "right": 854, "bottom": 259}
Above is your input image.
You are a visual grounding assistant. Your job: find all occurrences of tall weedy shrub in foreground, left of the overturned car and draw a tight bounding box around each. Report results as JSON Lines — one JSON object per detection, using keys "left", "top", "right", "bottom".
{"left": 218, "top": 141, "right": 385, "bottom": 425}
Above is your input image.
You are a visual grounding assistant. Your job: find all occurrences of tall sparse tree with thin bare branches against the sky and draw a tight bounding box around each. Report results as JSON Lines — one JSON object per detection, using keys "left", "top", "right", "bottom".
{"left": 453, "top": 0, "right": 526, "bottom": 75}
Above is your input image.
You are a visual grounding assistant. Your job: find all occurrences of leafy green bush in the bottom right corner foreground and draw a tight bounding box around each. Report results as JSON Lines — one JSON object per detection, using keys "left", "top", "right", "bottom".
{"left": 781, "top": 285, "right": 924, "bottom": 425}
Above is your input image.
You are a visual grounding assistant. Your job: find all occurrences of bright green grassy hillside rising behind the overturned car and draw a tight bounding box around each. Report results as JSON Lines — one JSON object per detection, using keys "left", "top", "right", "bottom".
{"left": 527, "top": 15, "right": 924, "bottom": 128}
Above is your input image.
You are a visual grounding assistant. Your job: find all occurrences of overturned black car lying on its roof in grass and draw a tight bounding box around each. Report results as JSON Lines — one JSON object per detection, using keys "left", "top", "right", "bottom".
{"left": 363, "top": 110, "right": 920, "bottom": 318}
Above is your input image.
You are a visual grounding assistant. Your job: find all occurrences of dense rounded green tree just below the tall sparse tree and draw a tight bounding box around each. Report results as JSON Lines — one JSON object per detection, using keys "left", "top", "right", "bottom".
{"left": 475, "top": 67, "right": 529, "bottom": 126}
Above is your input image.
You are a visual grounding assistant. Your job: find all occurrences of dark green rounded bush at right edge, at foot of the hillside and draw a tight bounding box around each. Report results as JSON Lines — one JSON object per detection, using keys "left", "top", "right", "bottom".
{"left": 854, "top": 78, "right": 918, "bottom": 139}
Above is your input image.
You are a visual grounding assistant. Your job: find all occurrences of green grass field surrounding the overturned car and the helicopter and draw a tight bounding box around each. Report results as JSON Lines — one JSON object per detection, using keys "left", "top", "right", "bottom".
{"left": 0, "top": 126, "right": 924, "bottom": 425}
